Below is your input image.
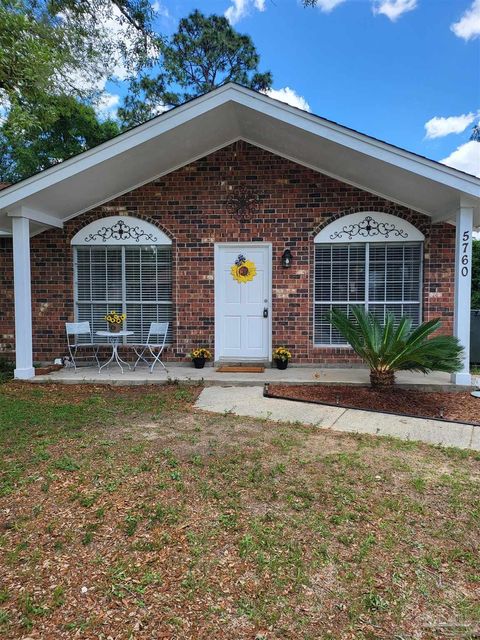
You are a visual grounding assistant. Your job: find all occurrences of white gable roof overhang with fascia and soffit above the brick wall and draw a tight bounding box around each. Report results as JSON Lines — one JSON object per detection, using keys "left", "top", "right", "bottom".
{"left": 0, "top": 83, "right": 480, "bottom": 233}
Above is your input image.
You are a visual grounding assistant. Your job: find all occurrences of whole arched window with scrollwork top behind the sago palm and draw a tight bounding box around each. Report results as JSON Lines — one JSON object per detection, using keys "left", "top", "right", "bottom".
{"left": 314, "top": 212, "right": 425, "bottom": 346}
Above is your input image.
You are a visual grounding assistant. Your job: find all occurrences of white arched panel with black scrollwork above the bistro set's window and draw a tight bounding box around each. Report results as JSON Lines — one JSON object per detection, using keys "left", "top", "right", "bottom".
{"left": 71, "top": 216, "right": 172, "bottom": 247}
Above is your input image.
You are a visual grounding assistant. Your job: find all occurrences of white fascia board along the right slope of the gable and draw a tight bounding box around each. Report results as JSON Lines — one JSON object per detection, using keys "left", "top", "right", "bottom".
{"left": 229, "top": 87, "right": 480, "bottom": 198}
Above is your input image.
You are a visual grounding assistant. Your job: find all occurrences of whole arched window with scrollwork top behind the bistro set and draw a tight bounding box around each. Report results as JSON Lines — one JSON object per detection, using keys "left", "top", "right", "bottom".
{"left": 72, "top": 216, "right": 172, "bottom": 343}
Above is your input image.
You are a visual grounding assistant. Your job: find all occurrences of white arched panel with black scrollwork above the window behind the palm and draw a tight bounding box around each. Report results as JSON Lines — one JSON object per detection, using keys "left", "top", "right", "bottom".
{"left": 314, "top": 211, "right": 425, "bottom": 244}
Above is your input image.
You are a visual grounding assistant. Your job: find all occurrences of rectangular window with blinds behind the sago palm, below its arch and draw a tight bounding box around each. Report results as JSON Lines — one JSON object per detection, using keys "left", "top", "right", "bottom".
{"left": 314, "top": 242, "right": 423, "bottom": 345}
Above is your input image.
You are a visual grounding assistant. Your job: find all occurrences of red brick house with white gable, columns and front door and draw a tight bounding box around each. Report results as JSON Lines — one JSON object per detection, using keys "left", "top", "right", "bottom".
{"left": 0, "top": 84, "right": 480, "bottom": 384}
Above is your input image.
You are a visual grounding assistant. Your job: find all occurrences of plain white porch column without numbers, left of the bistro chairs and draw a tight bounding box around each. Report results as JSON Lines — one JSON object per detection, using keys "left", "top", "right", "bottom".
{"left": 12, "top": 217, "right": 35, "bottom": 380}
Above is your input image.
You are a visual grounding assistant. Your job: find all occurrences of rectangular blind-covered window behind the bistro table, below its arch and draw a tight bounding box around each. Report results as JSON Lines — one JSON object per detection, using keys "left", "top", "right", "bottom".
{"left": 74, "top": 245, "right": 172, "bottom": 343}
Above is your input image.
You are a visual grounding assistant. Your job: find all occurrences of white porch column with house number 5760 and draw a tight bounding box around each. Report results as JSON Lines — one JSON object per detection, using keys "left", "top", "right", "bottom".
{"left": 452, "top": 206, "right": 473, "bottom": 385}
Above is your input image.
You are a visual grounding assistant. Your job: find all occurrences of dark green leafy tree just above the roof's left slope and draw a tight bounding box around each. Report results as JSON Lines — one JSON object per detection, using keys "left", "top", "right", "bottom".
{"left": 0, "top": 95, "right": 120, "bottom": 182}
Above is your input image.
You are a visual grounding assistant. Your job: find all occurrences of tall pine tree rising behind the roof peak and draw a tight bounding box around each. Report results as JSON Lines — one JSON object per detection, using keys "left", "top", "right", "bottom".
{"left": 118, "top": 11, "right": 272, "bottom": 125}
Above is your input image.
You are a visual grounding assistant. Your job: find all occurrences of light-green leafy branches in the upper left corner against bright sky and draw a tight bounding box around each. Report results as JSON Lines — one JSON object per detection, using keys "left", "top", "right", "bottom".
{"left": 0, "top": 0, "right": 158, "bottom": 129}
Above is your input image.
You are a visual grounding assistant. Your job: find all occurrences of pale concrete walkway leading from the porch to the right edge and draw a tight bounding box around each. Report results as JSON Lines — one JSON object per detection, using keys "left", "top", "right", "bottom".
{"left": 196, "top": 386, "right": 480, "bottom": 451}
